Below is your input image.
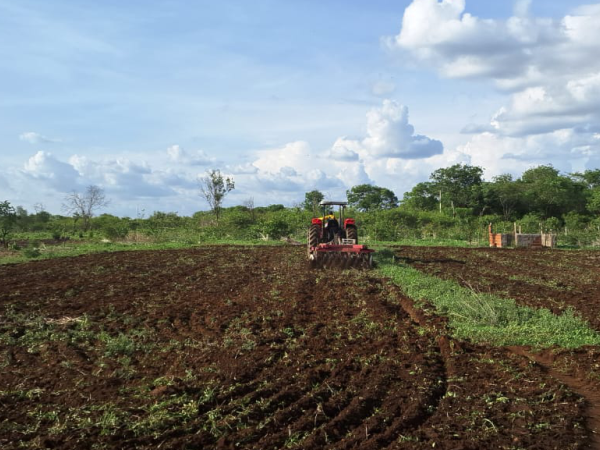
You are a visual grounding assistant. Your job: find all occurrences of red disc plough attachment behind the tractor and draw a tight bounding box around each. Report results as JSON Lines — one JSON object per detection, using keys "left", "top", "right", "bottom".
{"left": 308, "top": 244, "right": 375, "bottom": 269}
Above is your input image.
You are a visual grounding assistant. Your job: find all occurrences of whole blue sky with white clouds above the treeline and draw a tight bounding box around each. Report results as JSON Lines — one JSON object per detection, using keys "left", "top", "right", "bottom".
{"left": 0, "top": 0, "right": 600, "bottom": 216}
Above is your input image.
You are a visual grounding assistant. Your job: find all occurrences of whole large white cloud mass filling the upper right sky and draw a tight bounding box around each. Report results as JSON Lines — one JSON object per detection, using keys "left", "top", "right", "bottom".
{"left": 385, "top": 0, "right": 600, "bottom": 175}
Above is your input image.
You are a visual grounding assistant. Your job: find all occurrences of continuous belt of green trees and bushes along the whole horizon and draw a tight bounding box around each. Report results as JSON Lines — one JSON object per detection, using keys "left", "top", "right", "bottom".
{"left": 0, "top": 164, "right": 600, "bottom": 246}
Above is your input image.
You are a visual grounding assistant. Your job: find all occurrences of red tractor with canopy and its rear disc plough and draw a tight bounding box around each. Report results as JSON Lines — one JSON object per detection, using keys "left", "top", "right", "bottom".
{"left": 308, "top": 200, "right": 375, "bottom": 268}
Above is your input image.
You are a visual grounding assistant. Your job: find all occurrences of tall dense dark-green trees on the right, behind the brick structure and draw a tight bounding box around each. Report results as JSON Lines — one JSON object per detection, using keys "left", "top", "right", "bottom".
{"left": 402, "top": 164, "right": 600, "bottom": 222}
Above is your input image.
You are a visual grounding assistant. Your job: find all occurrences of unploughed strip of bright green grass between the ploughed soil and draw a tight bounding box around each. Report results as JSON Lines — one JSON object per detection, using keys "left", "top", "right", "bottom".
{"left": 376, "top": 250, "right": 600, "bottom": 348}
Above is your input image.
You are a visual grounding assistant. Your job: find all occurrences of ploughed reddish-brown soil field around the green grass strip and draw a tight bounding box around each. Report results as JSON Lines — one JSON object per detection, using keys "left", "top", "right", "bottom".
{"left": 0, "top": 246, "right": 600, "bottom": 449}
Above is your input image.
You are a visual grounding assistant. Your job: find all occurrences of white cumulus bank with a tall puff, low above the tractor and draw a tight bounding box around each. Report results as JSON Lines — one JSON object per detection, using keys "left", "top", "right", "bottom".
{"left": 239, "top": 99, "right": 450, "bottom": 201}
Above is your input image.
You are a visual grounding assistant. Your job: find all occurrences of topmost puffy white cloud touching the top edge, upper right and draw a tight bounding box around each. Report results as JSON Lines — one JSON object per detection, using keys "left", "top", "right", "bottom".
{"left": 386, "top": 0, "right": 569, "bottom": 79}
